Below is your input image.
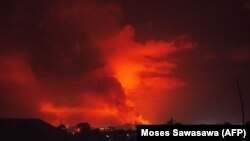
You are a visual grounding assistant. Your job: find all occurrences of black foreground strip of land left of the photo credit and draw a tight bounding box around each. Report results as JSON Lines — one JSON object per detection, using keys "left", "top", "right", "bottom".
{"left": 0, "top": 119, "right": 136, "bottom": 141}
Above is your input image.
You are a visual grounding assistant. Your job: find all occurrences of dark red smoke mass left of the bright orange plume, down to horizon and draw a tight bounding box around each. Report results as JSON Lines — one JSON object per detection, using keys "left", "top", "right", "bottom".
{"left": 0, "top": 0, "right": 149, "bottom": 125}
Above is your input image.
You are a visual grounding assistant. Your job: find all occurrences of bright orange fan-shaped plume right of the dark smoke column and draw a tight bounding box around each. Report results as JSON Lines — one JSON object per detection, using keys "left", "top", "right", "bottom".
{"left": 96, "top": 26, "right": 195, "bottom": 123}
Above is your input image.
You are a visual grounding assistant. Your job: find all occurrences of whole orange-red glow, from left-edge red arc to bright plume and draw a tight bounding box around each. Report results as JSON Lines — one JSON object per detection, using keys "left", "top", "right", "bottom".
{"left": 0, "top": 26, "right": 193, "bottom": 126}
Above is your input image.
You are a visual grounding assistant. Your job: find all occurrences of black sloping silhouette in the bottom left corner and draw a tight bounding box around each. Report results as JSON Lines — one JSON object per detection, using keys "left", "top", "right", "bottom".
{"left": 0, "top": 119, "right": 72, "bottom": 141}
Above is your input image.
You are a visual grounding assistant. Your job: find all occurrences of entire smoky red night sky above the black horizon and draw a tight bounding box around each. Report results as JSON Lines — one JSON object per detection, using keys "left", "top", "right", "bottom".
{"left": 0, "top": 0, "right": 250, "bottom": 126}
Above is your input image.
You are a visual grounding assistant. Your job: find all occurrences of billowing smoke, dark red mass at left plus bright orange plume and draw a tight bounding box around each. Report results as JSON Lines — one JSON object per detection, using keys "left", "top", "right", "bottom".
{"left": 0, "top": 0, "right": 195, "bottom": 126}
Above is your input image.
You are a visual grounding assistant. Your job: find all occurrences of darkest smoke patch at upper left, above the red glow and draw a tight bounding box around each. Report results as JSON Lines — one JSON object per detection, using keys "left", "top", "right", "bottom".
{"left": 1, "top": 1, "right": 105, "bottom": 77}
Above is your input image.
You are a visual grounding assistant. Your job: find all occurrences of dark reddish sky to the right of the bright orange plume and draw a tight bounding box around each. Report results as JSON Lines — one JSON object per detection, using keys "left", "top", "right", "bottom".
{"left": 118, "top": 0, "right": 250, "bottom": 123}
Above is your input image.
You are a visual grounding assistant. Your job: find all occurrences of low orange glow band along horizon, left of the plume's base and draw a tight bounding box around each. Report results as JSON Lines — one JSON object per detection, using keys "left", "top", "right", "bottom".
{"left": 40, "top": 94, "right": 149, "bottom": 126}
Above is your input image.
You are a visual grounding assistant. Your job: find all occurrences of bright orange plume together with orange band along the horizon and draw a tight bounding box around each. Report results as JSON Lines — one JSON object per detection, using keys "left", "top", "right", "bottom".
{"left": 37, "top": 4, "right": 195, "bottom": 125}
